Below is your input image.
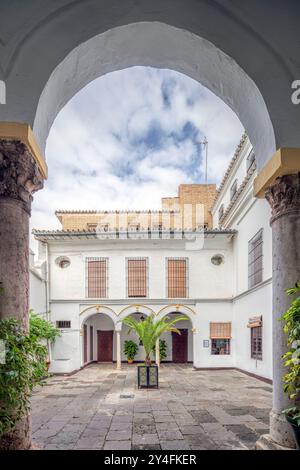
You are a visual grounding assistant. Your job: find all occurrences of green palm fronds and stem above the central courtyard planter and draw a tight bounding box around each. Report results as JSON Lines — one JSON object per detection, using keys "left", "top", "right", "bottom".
{"left": 123, "top": 314, "right": 187, "bottom": 365}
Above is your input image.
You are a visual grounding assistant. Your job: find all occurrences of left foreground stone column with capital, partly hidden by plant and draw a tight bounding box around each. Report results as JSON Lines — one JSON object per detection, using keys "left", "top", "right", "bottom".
{"left": 0, "top": 139, "right": 43, "bottom": 449}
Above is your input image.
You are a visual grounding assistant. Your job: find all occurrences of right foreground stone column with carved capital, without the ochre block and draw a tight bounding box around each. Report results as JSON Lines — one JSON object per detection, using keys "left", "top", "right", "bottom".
{"left": 265, "top": 173, "right": 300, "bottom": 448}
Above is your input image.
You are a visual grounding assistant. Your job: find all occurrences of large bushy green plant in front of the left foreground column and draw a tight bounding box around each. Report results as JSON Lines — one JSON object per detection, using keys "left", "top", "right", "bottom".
{"left": 0, "top": 312, "right": 60, "bottom": 435}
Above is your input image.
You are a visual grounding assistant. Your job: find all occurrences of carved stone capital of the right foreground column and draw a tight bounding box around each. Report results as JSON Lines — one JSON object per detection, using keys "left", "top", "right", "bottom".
{"left": 265, "top": 173, "right": 300, "bottom": 224}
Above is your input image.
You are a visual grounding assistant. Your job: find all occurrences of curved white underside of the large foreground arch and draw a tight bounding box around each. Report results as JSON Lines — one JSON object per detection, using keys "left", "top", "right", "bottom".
{"left": 33, "top": 22, "right": 276, "bottom": 169}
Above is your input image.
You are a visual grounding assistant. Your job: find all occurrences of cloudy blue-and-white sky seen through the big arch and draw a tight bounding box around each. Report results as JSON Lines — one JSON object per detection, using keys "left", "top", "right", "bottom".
{"left": 31, "top": 67, "right": 243, "bottom": 246}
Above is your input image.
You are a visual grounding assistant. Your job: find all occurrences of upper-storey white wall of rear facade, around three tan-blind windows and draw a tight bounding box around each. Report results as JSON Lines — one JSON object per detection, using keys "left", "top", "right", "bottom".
{"left": 49, "top": 239, "right": 233, "bottom": 300}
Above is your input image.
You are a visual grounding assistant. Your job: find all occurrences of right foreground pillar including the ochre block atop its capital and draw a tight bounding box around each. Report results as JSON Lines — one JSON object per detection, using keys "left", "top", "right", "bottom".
{"left": 254, "top": 149, "right": 300, "bottom": 449}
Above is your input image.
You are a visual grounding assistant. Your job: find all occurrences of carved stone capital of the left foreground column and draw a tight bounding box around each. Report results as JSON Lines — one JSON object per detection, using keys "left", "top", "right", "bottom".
{"left": 0, "top": 138, "right": 44, "bottom": 214}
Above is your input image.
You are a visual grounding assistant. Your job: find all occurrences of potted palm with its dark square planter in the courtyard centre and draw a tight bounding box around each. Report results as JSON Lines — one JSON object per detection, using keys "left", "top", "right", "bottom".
{"left": 123, "top": 314, "right": 187, "bottom": 388}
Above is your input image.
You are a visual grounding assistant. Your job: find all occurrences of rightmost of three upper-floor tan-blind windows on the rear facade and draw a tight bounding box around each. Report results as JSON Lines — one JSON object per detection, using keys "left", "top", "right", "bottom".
{"left": 167, "top": 258, "right": 188, "bottom": 298}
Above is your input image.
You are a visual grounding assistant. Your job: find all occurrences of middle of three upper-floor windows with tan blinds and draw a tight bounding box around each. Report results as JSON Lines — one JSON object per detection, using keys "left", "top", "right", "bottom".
{"left": 126, "top": 258, "right": 148, "bottom": 297}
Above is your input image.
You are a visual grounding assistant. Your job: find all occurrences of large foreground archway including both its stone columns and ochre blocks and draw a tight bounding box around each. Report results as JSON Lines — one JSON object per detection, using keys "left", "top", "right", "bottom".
{"left": 0, "top": 4, "right": 300, "bottom": 452}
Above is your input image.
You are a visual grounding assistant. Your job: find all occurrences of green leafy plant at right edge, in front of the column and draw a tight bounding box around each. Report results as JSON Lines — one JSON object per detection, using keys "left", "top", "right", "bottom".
{"left": 281, "top": 282, "right": 300, "bottom": 450}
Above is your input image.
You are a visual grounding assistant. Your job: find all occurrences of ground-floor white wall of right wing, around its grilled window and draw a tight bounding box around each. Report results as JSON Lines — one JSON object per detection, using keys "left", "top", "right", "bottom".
{"left": 233, "top": 283, "right": 272, "bottom": 379}
